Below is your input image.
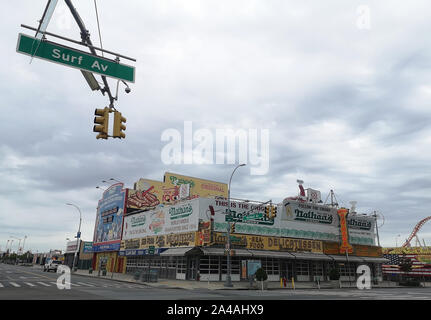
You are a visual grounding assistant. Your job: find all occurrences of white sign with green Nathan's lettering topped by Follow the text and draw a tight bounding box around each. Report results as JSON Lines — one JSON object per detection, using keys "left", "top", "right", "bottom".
{"left": 282, "top": 201, "right": 336, "bottom": 225}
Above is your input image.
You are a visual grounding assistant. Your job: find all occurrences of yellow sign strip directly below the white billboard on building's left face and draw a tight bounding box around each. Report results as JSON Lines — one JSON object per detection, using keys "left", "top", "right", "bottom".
{"left": 121, "top": 232, "right": 198, "bottom": 250}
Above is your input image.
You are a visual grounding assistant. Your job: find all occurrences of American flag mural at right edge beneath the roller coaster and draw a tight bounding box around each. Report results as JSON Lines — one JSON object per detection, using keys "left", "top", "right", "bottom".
{"left": 382, "top": 254, "right": 431, "bottom": 277}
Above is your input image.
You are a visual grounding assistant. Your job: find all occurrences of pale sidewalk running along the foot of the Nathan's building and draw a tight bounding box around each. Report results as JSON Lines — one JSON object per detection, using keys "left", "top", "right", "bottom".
{"left": 73, "top": 270, "right": 399, "bottom": 290}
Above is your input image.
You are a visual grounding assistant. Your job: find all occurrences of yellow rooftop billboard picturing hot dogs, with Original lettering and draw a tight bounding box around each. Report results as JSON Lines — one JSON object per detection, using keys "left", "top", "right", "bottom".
{"left": 127, "top": 172, "right": 227, "bottom": 210}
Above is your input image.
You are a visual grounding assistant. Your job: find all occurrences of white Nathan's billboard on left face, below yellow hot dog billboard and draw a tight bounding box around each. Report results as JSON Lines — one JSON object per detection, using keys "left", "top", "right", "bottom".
{"left": 122, "top": 199, "right": 199, "bottom": 240}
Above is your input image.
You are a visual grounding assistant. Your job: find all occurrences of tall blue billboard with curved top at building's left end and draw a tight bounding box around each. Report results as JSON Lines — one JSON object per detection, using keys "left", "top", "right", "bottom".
{"left": 93, "top": 183, "right": 127, "bottom": 252}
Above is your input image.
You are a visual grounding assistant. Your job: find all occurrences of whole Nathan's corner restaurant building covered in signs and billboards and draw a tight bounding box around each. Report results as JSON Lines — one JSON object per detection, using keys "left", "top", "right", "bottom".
{"left": 93, "top": 173, "right": 387, "bottom": 281}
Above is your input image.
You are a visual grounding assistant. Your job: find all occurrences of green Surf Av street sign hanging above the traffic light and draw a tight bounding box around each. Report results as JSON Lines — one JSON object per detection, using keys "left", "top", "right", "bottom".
{"left": 16, "top": 33, "right": 135, "bottom": 82}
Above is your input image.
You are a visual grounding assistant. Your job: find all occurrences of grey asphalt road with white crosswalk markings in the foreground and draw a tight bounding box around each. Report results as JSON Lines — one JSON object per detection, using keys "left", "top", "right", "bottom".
{"left": 0, "top": 264, "right": 431, "bottom": 300}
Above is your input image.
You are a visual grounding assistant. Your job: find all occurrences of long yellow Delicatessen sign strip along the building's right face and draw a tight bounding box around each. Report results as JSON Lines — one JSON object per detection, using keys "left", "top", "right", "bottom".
{"left": 214, "top": 233, "right": 323, "bottom": 253}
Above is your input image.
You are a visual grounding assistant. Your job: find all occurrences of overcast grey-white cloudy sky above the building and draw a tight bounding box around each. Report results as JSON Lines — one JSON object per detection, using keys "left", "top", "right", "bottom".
{"left": 0, "top": 0, "right": 431, "bottom": 252}
